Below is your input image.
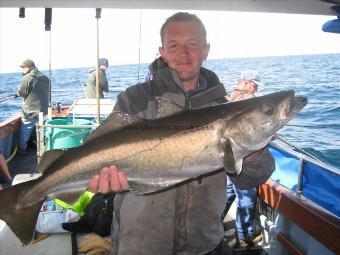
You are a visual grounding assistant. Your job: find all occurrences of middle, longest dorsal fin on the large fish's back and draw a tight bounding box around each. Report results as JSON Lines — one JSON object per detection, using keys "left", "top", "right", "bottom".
{"left": 84, "top": 111, "right": 143, "bottom": 144}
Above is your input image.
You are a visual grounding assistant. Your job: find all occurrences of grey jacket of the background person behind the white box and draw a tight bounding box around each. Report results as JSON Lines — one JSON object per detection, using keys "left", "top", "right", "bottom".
{"left": 84, "top": 68, "right": 109, "bottom": 98}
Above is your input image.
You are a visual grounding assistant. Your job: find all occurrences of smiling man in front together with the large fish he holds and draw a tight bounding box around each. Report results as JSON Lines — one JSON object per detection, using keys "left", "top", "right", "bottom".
{"left": 0, "top": 10, "right": 307, "bottom": 255}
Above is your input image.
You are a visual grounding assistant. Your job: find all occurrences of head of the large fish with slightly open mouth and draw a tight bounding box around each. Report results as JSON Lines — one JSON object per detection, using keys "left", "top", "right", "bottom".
{"left": 225, "top": 90, "right": 307, "bottom": 152}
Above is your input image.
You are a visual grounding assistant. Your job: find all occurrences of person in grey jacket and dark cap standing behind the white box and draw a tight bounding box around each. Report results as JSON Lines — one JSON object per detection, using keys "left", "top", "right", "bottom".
{"left": 84, "top": 58, "right": 109, "bottom": 98}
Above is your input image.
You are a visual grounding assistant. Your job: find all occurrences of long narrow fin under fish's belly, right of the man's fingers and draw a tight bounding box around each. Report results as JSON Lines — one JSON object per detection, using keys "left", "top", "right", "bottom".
{"left": 128, "top": 178, "right": 187, "bottom": 195}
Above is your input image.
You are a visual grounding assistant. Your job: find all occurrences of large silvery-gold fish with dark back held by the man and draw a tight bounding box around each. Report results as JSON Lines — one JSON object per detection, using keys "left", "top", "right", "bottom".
{"left": 0, "top": 91, "right": 307, "bottom": 244}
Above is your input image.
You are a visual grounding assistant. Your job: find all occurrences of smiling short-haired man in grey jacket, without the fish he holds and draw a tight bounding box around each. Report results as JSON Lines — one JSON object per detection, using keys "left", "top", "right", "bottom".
{"left": 89, "top": 12, "right": 272, "bottom": 255}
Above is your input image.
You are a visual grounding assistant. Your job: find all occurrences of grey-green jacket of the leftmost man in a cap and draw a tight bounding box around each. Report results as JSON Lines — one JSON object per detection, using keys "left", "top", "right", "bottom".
{"left": 17, "top": 67, "right": 49, "bottom": 119}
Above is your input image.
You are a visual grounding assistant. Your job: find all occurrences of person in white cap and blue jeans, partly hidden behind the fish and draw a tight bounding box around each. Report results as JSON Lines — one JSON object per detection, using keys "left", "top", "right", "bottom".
{"left": 222, "top": 70, "right": 262, "bottom": 248}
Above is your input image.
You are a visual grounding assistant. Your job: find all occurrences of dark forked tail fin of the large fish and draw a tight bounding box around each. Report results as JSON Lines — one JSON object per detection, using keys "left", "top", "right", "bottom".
{"left": 0, "top": 180, "right": 45, "bottom": 245}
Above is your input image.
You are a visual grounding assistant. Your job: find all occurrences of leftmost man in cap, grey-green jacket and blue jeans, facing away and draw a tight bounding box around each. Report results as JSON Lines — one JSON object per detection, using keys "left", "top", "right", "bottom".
{"left": 16, "top": 59, "right": 49, "bottom": 153}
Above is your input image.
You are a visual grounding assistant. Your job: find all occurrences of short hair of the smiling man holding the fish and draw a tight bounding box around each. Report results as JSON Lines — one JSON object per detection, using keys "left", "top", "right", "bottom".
{"left": 160, "top": 12, "right": 207, "bottom": 45}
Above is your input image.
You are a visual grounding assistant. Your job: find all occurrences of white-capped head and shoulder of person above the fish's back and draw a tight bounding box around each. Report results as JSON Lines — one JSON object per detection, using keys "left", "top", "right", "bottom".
{"left": 227, "top": 70, "right": 262, "bottom": 102}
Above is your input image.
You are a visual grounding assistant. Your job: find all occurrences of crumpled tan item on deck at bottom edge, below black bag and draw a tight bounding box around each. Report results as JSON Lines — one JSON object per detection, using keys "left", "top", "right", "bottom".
{"left": 78, "top": 234, "right": 111, "bottom": 255}
